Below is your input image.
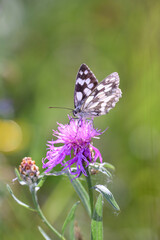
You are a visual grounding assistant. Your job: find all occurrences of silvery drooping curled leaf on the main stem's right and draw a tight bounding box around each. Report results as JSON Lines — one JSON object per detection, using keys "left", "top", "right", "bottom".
{"left": 93, "top": 185, "right": 120, "bottom": 211}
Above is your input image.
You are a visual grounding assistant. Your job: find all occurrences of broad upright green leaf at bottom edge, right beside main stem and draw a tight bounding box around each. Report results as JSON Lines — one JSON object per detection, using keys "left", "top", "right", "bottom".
{"left": 91, "top": 194, "right": 103, "bottom": 240}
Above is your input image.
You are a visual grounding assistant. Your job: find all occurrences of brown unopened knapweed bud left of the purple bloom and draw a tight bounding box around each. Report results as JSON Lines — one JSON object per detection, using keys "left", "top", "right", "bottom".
{"left": 19, "top": 157, "right": 40, "bottom": 184}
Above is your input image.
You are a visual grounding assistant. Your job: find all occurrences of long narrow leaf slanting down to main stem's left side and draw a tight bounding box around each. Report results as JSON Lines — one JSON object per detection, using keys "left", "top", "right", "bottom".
{"left": 67, "top": 172, "right": 91, "bottom": 217}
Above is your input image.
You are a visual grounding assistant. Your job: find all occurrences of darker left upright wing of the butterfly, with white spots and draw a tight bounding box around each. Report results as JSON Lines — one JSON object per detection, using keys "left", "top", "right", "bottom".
{"left": 74, "top": 64, "right": 98, "bottom": 108}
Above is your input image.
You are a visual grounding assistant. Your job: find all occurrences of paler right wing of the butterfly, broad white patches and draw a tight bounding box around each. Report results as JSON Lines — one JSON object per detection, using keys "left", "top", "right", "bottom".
{"left": 81, "top": 72, "right": 122, "bottom": 117}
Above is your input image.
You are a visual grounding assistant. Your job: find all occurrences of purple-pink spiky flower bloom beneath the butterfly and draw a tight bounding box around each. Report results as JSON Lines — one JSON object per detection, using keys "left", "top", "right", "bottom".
{"left": 43, "top": 118, "right": 102, "bottom": 177}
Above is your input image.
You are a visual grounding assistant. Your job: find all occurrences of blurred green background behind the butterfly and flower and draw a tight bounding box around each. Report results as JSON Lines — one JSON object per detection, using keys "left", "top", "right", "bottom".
{"left": 0, "top": 0, "right": 160, "bottom": 240}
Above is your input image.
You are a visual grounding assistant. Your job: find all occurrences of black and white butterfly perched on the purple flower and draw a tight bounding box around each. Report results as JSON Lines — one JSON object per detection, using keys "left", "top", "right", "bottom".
{"left": 73, "top": 64, "right": 122, "bottom": 118}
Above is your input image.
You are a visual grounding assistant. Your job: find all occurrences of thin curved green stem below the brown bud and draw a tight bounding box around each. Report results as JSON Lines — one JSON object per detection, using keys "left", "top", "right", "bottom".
{"left": 30, "top": 188, "right": 65, "bottom": 240}
